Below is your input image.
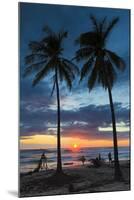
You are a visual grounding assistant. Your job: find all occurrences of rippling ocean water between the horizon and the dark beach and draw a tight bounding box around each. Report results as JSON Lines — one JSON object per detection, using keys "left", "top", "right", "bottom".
{"left": 20, "top": 147, "right": 130, "bottom": 173}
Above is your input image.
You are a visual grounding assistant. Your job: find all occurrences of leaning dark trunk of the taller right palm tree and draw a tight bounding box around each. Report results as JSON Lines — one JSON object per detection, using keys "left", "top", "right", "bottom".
{"left": 108, "top": 84, "right": 122, "bottom": 180}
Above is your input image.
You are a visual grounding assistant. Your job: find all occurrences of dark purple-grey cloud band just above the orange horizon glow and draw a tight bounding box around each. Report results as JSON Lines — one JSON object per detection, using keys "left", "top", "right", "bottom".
{"left": 21, "top": 103, "right": 129, "bottom": 139}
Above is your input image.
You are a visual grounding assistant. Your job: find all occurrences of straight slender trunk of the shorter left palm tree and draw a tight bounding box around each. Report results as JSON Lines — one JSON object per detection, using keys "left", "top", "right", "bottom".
{"left": 55, "top": 72, "right": 62, "bottom": 173}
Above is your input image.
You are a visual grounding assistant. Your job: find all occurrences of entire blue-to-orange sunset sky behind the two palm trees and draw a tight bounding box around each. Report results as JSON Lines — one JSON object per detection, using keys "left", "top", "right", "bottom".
{"left": 20, "top": 3, "right": 130, "bottom": 148}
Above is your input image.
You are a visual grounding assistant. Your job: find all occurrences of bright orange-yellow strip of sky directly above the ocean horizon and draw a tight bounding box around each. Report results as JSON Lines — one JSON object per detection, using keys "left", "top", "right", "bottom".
{"left": 20, "top": 135, "right": 129, "bottom": 149}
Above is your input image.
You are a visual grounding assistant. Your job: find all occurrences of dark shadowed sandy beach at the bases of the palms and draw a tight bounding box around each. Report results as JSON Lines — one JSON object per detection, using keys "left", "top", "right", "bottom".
{"left": 20, "top": 161, "right": 130, "bottom": 197}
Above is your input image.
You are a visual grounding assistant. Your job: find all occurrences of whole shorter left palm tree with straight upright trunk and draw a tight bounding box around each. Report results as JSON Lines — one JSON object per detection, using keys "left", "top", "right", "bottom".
{"left": 24, "top": 27, "right": 78, "bottom": 173}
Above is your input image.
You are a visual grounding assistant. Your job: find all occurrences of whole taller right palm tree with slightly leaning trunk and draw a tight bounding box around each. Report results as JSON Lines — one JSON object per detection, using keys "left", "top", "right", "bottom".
{"left": 75, "top": 15, "right": 125, "bottom": 180}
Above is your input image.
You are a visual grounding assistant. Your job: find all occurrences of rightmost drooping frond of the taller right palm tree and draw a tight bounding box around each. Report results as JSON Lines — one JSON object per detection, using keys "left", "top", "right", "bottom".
{"left": 106, "top": 50, "right": 126, "bottom": 71}
